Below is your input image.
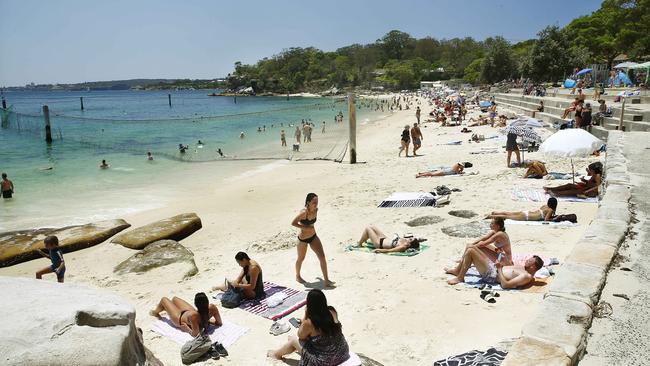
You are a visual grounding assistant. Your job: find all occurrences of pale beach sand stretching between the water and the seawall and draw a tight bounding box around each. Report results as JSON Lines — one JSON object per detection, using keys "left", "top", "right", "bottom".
{"left": 0, "top": 96, "right": 597, "bottom": 365}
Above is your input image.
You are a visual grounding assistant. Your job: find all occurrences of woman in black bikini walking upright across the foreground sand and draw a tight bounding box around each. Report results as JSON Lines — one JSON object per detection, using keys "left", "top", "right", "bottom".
{"left": 291, "top": 193, "right": 334, "bottom": 287}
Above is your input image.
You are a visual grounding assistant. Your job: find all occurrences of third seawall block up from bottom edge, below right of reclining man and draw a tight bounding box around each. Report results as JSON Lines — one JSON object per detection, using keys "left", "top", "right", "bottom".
{"left": 548, "top": 262, "right": 605, "bottom": 306}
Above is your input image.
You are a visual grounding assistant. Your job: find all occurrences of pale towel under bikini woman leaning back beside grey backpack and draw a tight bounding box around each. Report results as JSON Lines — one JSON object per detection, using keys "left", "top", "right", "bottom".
{"left": 151, "top": 317, "right": 249, "bottom": 348}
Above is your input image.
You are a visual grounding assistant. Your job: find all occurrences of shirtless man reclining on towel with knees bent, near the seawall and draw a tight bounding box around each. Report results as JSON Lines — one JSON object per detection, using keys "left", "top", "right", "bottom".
{"left": 447, "top": 247, "right": 544, "bottom": 289}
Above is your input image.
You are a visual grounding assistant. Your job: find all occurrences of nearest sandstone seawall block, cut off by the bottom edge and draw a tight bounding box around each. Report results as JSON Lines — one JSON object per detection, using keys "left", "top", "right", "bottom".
{"left": 501, "top": 337, "right": 571, "bottom": 366}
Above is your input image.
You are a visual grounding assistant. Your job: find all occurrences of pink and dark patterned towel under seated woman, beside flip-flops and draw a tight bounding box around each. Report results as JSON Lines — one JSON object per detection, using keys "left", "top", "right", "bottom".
{"left": 213, "top": 281, "right": 307, "bottom": 320}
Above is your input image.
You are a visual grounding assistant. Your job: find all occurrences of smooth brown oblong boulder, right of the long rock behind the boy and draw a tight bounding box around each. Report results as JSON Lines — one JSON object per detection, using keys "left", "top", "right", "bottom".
{"left": 111, "top": 213, "right": 202, "bottom": 249}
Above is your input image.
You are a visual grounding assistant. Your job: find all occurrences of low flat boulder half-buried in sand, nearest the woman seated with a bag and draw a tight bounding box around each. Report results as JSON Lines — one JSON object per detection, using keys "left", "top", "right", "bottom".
{"left": 114, "top": 240, "right": 199, "bottom": 278}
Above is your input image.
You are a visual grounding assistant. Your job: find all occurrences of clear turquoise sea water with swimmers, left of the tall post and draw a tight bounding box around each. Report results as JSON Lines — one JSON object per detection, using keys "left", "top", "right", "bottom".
{"left": 0, "top": 90, "right": 383, "bottom": 231}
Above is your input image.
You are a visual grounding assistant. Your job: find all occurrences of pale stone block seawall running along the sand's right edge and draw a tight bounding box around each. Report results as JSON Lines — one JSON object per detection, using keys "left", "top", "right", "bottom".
{"left": 502, "top": 131, "right": 632, "bottom": 366}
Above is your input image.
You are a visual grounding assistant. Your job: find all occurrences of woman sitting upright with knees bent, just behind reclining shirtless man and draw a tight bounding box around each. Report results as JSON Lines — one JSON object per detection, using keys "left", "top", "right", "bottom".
{"left": 445, "top": 218, "right": 513, "bottom": 276}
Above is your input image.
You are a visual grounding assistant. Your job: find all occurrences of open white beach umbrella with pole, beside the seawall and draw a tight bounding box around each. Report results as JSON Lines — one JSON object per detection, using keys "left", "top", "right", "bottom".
{"left": 539, "top": 128, "right": 605, "bottom": 183}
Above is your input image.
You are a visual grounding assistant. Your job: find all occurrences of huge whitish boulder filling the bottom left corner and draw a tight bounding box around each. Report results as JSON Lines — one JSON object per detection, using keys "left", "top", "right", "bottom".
{"left": 0, "top": 277, "right": 146, "bottom": 366}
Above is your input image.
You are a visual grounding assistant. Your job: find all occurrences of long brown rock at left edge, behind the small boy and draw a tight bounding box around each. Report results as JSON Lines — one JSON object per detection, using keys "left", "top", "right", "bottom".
{"left": 0, "top": 219, "right": 131, "bottom": 267}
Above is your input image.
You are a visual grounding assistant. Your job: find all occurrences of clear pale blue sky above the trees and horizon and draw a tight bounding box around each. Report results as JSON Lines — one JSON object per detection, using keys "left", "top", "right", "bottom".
{"left": 0, "top": 0, "right": 601, "bottom": 87}
